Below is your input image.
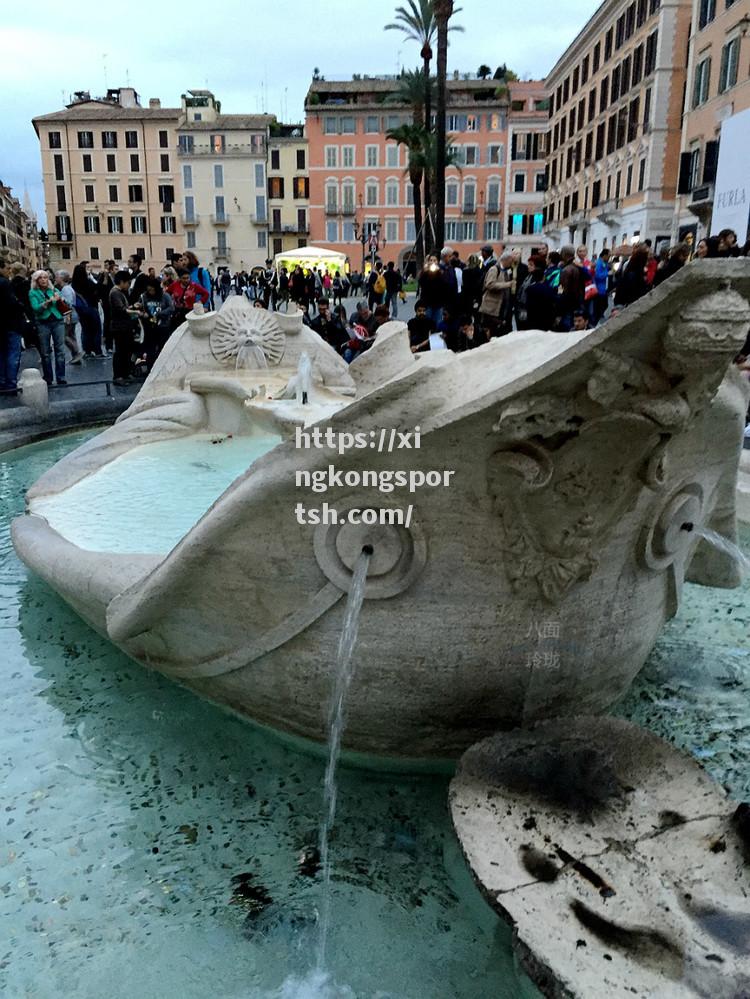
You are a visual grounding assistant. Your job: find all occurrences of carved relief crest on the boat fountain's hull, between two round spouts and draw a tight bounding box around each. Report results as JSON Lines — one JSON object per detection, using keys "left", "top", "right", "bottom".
{"left": 487, "top": 282, "right": 750, "bottom": 604}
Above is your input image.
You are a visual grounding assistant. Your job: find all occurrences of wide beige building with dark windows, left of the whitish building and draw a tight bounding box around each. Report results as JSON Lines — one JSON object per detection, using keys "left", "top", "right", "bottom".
{"left": 33, "top": 87, "right": 184, "bottom": 268}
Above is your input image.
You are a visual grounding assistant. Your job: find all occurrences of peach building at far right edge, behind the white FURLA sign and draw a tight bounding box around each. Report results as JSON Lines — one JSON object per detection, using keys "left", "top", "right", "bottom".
{"left": 673, "top": 0, "right": 750, "bottom": 243}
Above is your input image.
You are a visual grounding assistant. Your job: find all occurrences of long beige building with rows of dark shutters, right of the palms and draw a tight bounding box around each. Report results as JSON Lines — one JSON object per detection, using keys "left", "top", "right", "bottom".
{"left": 545, "top": 0, "right": 692, "bottom": 252}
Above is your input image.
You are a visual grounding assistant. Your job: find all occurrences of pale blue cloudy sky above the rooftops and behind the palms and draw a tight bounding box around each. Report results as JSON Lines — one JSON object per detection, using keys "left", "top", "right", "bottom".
{"left": 0, "top": 0, "right": 601, "bottom": 220}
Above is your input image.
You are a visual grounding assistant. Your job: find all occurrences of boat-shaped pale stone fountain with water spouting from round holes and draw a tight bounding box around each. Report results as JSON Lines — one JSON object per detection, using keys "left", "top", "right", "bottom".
{"left": 13, "top": 262, "right": 750, "bottom": 759}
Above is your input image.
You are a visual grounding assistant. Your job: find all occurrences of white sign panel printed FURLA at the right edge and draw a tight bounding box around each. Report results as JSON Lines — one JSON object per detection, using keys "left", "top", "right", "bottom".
{"left": 711, "top": 109, "right": 750, "bottom": 246}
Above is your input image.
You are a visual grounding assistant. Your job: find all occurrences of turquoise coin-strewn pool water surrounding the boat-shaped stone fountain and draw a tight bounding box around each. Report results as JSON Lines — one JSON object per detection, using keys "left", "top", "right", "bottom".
{"left": 0, "top": 435, "right": 750, "bottom": 999}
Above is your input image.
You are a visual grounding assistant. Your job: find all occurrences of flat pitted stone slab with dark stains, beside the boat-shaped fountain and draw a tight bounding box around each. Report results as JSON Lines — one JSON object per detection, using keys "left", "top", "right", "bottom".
{"left": 450, "top": 717, "right": 750, "bottom": 999}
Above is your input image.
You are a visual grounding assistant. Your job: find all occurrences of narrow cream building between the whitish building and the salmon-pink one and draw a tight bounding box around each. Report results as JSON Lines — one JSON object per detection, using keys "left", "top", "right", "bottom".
{"left": 268, "top": 122, "right": 310, "bottom": 257}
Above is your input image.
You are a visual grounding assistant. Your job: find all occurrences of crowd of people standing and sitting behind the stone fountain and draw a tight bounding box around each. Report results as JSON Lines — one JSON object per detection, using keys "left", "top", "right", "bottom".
{"left": 0, "top": 229, "right": 750, "bottom": 394}
